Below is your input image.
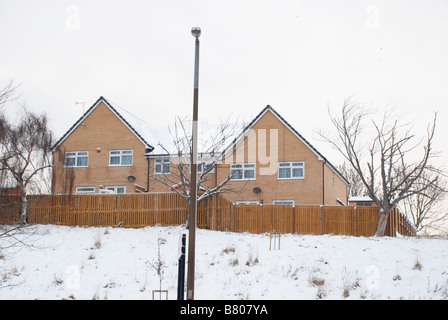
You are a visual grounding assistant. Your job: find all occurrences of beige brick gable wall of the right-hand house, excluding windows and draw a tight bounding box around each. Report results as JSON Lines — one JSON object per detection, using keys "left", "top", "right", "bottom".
{"left": 214, "top": 111, "right": 346, "bottom": 205}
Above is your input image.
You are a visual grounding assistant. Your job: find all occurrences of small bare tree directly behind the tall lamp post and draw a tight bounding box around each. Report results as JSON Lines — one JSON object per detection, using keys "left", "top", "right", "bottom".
{"left": 150, "top": 117, "right": 247, "bottom": 227}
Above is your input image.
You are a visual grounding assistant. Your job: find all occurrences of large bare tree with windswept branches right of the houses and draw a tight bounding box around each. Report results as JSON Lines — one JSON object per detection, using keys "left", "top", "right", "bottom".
{"left": 319, "top": 98, "right": 442, "bottom": 236}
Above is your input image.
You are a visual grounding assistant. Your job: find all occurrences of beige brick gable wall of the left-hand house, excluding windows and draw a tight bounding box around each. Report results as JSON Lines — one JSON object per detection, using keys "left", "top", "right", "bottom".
{"left": 53, "top": 102, "right": 147, "bottom": 193}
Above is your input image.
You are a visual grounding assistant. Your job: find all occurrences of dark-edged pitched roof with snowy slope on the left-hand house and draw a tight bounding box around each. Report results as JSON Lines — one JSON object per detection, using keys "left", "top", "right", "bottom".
{"left": 51, "top": 96, "right": 155, "bottom": 152}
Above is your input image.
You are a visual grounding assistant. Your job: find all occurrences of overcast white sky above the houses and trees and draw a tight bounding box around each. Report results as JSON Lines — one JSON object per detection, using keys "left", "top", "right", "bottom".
{"left": 0, "top": 0, "right": 448, "bottom": 169}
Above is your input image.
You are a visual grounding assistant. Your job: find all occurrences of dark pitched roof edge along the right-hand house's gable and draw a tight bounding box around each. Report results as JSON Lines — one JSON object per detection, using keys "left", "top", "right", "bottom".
{"left": 223, "top": 105, "right": 350, "bottom": 184}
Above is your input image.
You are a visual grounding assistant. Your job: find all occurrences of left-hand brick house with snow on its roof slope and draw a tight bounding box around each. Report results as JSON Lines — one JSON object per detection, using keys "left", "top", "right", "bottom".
{"left": 52, "top": 97, "right": 155, "bottom": 194}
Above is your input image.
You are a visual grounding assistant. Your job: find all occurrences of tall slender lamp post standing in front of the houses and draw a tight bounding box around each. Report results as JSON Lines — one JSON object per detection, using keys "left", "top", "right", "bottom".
{"left": 187, "top": 28, "right": 201, "bottom": 300}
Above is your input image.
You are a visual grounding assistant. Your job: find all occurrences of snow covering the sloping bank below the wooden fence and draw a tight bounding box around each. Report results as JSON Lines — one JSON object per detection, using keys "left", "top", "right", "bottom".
{"left": 0, "top": 225, "right": 448, "bottom": 300}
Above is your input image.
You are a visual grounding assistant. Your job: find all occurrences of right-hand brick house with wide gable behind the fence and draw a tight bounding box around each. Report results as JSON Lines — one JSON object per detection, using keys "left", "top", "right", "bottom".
{"left": 216, "top": 105, "right": 349, "bottom": 205}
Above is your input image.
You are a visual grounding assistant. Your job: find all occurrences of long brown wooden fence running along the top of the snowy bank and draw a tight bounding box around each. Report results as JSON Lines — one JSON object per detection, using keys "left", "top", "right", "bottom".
{"left": 0, "top": 193, "right": 416, "bottom": 236}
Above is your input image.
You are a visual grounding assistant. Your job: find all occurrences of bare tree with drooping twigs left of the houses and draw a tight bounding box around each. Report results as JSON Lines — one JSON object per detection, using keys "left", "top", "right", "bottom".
{"left": 0, "top": 108, "right": 53, "bottom": 224}
